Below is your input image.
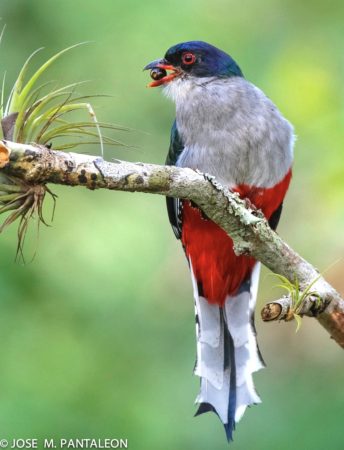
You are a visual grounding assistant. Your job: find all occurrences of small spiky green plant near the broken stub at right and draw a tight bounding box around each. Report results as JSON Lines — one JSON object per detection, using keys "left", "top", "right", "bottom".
{"left": 273, "top": 273, "right": 322, "bottom": 332}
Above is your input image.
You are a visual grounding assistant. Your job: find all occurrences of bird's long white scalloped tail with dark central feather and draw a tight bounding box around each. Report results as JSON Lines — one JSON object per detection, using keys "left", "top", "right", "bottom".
{"left": 190, "top": 261, "right": 264, "bottom": 440}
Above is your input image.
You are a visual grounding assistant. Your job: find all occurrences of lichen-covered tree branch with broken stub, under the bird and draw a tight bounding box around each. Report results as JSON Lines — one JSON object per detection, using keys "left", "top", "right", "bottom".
{"left": 0, "top": 141, "right": 344, "bottom": 348}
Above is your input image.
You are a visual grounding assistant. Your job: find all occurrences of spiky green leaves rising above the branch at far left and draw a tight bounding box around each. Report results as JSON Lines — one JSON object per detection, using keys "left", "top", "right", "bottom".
{"left": 0, "top": 43, "right": 123, "bottom": 149}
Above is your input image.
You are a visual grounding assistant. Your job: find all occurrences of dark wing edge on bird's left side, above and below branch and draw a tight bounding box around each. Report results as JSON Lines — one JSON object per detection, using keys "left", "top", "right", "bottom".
{"left": 166, "top": 121, "right": 184, "bottom": 239}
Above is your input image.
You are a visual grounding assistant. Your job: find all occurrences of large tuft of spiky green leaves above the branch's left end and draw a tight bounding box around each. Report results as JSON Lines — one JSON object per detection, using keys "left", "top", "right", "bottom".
{"left": 0, "top": 44, "right": 123, "bottom": 149}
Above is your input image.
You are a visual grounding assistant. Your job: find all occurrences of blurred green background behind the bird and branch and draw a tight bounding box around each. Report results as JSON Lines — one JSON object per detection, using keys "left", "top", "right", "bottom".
{"left": 0, "top": 0, "right": 344, "bottom": 450}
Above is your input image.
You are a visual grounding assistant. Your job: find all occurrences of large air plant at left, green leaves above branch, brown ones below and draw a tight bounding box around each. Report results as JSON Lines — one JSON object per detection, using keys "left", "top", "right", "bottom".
{"left": 0, "top": 35, "right": 121, "bottom": 259}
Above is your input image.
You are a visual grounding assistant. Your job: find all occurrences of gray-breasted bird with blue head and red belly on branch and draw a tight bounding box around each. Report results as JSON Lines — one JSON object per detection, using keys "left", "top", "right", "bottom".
{"left": 144, "top": 41, "right": 295, "bottom": 442}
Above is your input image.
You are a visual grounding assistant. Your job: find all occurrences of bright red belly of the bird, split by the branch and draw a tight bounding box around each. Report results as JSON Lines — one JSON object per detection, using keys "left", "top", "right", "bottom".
{"left": 182, "top": 170, "right": 291, "bottom": 306}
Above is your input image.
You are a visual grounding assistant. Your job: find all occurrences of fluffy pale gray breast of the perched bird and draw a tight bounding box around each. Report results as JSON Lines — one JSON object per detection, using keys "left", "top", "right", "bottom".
{"left": 166, "top": 77, "right": 294, "bottom": 187}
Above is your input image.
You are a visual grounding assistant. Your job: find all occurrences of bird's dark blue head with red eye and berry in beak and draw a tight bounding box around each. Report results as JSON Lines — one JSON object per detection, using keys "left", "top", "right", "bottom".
{"left": 144, "top": 41, "right": 243, "bottom": 87}
